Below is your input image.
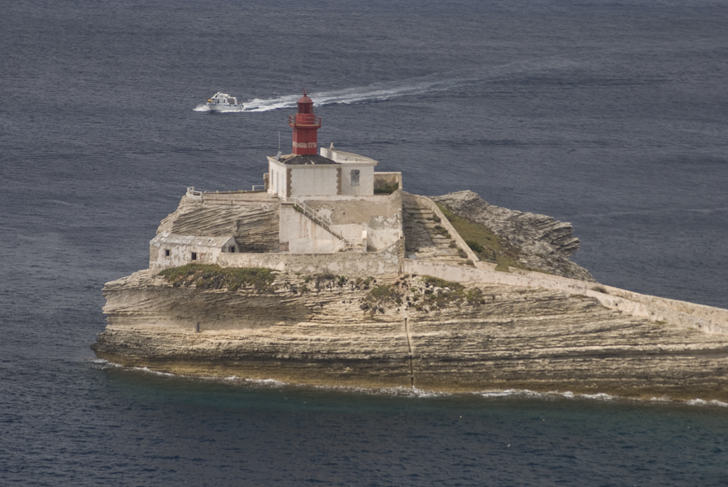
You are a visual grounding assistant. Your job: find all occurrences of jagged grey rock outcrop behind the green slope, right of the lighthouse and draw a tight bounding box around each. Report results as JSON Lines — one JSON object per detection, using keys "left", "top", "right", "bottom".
{"left": 432, "top": 191, "right": 595, "bottom": 282}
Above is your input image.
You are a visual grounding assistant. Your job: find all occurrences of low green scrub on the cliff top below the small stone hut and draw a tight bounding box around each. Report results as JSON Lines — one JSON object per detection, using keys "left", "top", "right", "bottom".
{"left": 159, "top": 264, "right": 275, "bottom": 291}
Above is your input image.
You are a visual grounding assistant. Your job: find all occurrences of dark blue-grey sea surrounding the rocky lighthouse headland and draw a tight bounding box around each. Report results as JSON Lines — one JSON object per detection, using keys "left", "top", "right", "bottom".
{"left": 0, "top": 0, "right": 728, "bottom": 487}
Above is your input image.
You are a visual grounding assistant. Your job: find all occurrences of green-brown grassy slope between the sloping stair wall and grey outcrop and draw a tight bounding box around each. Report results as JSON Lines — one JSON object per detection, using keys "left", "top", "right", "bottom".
{"left": 437, "top": 203, "right": 526, "bottom": 272}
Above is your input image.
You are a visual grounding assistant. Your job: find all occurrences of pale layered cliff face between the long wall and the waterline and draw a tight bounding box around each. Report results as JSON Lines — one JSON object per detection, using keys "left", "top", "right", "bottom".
{"left": 93, "top": 271, "right": 728, "bottom": 401}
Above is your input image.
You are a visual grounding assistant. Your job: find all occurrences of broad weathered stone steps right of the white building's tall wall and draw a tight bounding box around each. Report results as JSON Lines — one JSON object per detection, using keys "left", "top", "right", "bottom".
{"left": 402, "top": 194, "right": 467, "bottom": 265}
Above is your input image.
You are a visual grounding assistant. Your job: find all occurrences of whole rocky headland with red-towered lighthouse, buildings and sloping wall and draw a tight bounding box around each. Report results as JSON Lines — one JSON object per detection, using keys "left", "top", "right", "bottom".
{"left": 92, "top": 94, "right": 728, "bottom": 401}
